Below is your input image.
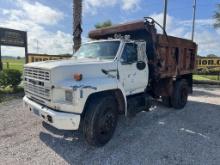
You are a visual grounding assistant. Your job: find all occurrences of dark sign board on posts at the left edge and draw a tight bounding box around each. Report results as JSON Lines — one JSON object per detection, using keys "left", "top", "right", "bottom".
{"left": 0, "top": 28, "right": 28, "bottom": 70}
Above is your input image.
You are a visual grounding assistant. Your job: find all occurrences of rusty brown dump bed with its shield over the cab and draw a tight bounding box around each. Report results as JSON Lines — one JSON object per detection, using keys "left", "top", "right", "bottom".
{"left": 89, "top": 21, "right": 197, "bottom": 80}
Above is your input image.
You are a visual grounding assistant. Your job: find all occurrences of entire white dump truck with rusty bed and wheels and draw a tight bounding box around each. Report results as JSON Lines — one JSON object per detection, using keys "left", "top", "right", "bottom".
{"left": 23, "top": 18, "right": 197, "bottom": 146}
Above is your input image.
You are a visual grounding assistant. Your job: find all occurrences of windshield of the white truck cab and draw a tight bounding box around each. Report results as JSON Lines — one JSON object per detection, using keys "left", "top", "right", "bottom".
{"left": 74, "top": 41, "right": 120, "bottom": 59}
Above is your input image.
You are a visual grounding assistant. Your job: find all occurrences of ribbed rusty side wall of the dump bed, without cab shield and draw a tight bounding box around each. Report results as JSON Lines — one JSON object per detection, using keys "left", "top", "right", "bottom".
{"left": 157, "top": 34, "right": 197, "bottom": 78}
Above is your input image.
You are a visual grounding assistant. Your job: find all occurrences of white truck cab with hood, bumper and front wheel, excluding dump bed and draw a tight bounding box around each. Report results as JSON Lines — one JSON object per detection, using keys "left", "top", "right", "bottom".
{"left": 23, "top": 38, "right": 149, "bottom": 146}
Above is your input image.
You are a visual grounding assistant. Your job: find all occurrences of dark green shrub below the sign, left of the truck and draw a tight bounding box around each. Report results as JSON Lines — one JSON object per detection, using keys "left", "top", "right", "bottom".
{"left": 0, "top": 69, "right": 22, "bottom": 89}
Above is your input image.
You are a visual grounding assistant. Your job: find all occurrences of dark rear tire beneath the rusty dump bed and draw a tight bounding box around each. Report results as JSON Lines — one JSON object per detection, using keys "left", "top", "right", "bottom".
{"left": 171, "top": 80, "right": 188, "bottom": 109}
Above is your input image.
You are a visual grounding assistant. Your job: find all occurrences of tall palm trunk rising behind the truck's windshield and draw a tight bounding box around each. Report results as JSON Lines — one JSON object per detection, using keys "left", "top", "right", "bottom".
{"left": 73, "top": 0, "right": 82, "bottom": 52}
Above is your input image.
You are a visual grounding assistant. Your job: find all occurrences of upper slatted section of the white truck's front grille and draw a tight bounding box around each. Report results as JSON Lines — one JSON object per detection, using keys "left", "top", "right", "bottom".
{"left": 24, "top": 67, "right": 50, "bottom": 81}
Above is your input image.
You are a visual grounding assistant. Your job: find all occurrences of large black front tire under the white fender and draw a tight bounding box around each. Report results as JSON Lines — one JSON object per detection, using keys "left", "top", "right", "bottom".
{"left": 83, "top": 96, "right": 118, "bottom": 147}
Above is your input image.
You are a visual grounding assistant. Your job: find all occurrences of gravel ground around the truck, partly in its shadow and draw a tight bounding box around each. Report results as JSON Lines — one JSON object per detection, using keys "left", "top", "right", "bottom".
{"left": 0, "top": 85, "right": 220, "bottom": 165}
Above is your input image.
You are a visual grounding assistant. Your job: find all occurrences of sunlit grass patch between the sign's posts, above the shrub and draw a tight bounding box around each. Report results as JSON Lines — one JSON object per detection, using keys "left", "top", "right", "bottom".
{"left": 2, "top": 59, "right": 25, "bottom": 72}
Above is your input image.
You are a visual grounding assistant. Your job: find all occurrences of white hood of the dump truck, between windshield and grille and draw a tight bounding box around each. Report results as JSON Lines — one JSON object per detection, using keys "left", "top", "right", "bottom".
{"left": 25, "top": 59, "right": 117, "bottom": 84}
